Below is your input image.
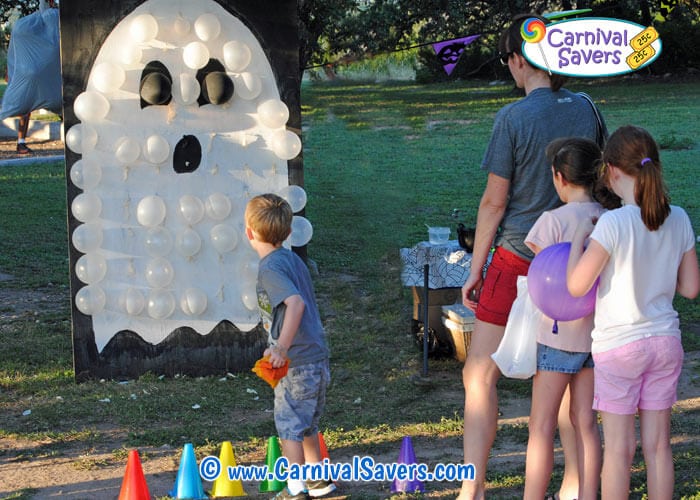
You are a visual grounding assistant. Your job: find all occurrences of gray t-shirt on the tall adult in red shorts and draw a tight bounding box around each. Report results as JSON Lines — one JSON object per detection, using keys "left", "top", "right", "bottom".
{"left": 481, "top": 88, "right": 597, "bottom": 260}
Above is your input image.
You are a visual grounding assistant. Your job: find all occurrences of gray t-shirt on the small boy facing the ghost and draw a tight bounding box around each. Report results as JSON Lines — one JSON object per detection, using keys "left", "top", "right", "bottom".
{"left": 257, "top": 247, "right": 328, "bottom": 367}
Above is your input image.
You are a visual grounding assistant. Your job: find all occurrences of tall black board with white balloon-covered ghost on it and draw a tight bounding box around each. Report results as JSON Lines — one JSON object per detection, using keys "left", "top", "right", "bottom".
{"left": 60, "top": 0, "right": 303, "bottom": 380}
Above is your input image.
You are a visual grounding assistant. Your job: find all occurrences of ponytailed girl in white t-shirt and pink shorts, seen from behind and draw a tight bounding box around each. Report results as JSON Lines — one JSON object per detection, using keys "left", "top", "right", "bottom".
{"left": 567, "top": 126, "right": 700, "bottom": 498}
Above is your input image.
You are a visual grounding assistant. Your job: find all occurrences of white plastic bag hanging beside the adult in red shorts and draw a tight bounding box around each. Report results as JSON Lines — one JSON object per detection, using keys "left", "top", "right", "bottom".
{"left": 491, "top": 276, "right": 545, "bottom": 379}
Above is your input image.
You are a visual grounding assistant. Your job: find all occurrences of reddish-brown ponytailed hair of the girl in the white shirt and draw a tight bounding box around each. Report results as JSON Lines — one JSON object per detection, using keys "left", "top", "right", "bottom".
{"left": 603, "top": 125, "right": 671, "bottom": 231}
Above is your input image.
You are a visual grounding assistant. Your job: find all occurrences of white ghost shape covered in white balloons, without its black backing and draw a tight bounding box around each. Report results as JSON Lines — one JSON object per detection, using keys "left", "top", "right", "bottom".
{"left": 66, "top": 0, "right": 311, "bottom": 351}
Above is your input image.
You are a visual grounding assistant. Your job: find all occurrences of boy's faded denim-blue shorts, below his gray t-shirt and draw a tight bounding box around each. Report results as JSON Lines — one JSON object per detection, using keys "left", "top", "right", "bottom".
{"left": 275, "top": 360, "right": 331, "bottom": 441}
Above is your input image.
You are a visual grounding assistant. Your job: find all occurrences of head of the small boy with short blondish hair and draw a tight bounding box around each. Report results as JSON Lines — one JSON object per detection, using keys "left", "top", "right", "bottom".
{"left": 245, "top": 193, "right": 294, "bottom": 246}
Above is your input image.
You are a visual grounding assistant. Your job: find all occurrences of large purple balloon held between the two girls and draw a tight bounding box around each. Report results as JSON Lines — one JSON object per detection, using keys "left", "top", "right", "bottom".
{"left": 527, "top": 243, "right": 598, "bottom": 321}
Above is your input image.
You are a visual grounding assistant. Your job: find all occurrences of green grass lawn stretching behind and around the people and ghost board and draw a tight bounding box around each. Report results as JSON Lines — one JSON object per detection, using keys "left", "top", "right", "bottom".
{"left": 0, "top": 78, "right": 700, "bottom": 498}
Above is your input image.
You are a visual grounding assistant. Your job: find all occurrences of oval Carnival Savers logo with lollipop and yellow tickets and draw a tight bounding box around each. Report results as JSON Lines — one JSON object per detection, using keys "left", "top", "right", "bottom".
{"left": 520, "top": 18, "right": 661, "bottom": 77}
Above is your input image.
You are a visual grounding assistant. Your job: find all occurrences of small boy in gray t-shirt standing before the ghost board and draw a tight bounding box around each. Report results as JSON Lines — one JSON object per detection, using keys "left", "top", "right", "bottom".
{"left": 245, "top": 194, "right": 335, "bottom": 500}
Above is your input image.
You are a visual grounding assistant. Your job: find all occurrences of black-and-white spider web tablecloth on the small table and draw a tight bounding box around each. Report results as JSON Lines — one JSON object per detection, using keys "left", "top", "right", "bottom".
{"left": 399, "top": 241, "right": 472, "bottom": 289}
